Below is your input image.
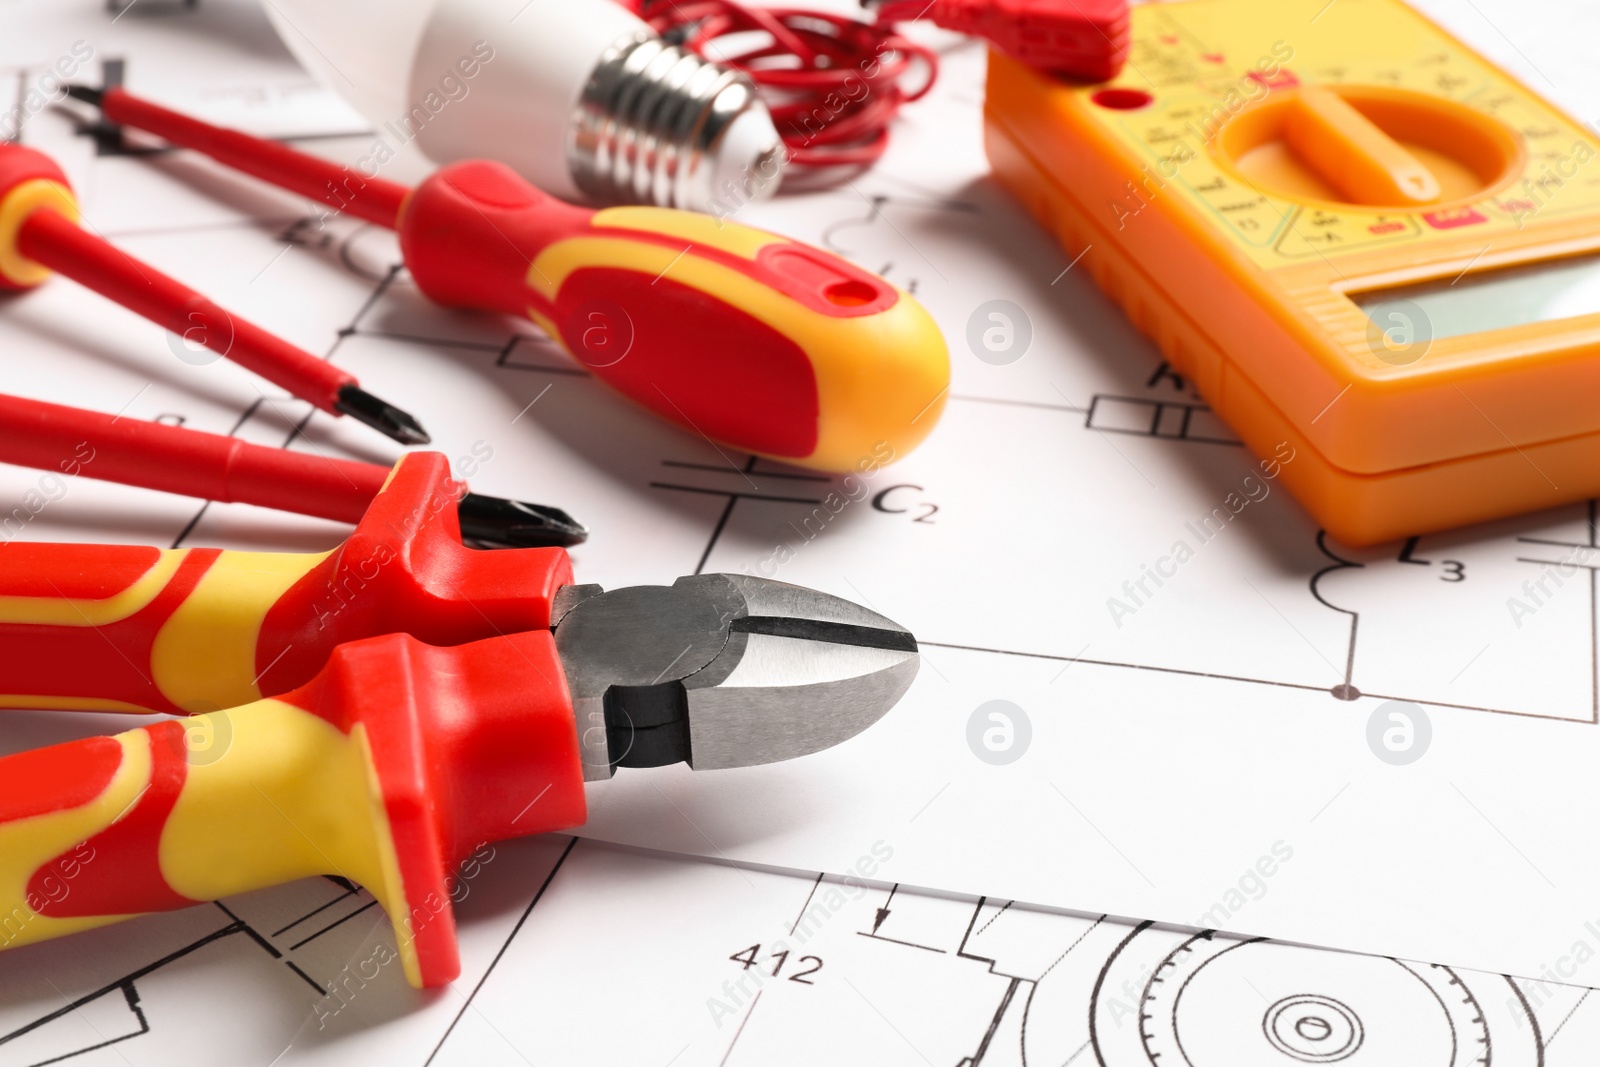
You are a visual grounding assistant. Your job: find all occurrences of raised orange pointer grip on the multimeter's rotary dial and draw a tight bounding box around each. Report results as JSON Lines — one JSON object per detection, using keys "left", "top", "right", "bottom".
{"left": 1283, "top": 85, "right": 1440, "bottom": 206}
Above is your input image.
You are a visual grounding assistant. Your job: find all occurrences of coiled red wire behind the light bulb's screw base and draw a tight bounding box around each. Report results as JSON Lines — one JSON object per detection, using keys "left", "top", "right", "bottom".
{"left": 627, "top": 0, "right": 939, "bottom": 166}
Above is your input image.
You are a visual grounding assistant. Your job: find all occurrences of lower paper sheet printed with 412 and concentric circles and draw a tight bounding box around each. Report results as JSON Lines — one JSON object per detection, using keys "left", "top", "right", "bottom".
{"left": 0, "top": 837, "right": 1600, "bottom": 1067}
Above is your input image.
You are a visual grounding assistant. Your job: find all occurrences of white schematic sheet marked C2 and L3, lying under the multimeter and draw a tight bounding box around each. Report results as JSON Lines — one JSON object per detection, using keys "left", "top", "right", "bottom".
{"left": 0, "top": 0, "right": 1600, "bottom": 1036}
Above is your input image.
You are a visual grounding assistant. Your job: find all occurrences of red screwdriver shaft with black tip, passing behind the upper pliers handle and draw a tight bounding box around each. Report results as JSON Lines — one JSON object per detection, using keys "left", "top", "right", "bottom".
{"left": 0, "top": 394, "right": 589, "bottom": 547}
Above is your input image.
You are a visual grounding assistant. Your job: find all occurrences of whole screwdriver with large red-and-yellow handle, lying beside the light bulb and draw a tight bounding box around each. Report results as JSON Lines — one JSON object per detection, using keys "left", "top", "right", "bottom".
{"left": 69, "top": 86, "right": 950, "bottom": 470}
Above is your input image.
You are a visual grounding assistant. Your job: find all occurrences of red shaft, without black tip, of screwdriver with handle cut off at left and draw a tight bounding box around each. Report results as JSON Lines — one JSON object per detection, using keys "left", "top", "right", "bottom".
{"left": 16, "top": 208, "right": 357, "bottom": 414}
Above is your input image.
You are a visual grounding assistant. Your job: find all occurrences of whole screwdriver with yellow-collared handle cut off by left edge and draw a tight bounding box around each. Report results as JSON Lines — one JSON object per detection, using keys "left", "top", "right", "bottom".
{"left": 0, "top": 144, "right": 430, "bottom": 445}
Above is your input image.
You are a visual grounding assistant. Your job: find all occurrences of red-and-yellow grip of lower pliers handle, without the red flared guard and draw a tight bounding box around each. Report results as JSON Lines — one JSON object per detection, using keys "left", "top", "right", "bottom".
{"left": 0, "top": 701, "right": 419, "bottom": 972}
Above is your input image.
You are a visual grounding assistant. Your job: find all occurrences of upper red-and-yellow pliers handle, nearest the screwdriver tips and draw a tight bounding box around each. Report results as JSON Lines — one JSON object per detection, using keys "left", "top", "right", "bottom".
{"left": 0, "top": 453, "right": 573, "bottom": 713}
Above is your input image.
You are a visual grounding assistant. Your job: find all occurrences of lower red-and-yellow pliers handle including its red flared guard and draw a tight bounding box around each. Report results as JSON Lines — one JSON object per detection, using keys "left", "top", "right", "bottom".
{"left": 0, "top": 632, "right": 586, "bottom": 987}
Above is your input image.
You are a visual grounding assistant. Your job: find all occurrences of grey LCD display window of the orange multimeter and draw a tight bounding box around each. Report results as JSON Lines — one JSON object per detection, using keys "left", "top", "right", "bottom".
{"left": 1350, "top": 256, "right": 1600, "bottom": 338}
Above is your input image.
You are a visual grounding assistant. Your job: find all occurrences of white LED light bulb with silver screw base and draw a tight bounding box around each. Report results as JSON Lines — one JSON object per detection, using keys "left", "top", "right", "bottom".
{"left": 264, "top": 0, "right": 784, "bottom": 214}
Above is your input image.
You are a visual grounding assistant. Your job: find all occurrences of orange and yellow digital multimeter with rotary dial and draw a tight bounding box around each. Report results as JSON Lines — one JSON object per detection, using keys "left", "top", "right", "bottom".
{"left": 984, "top": 0, "right": 1600, "bottom": 544}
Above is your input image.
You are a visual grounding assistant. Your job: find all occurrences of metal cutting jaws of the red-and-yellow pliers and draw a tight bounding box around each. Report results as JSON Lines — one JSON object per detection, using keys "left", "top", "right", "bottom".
{"left": 552, "top": 574, "right": 920, "bottom": 781}
